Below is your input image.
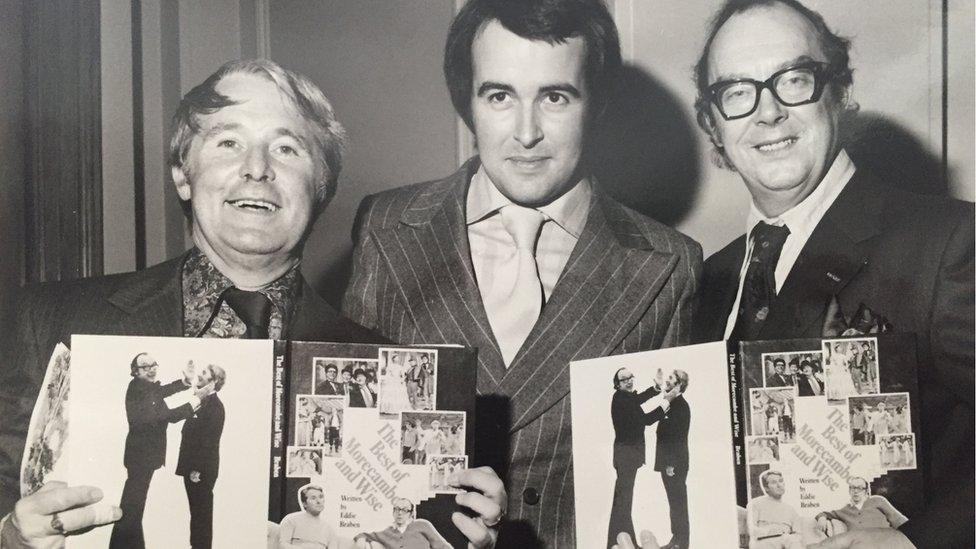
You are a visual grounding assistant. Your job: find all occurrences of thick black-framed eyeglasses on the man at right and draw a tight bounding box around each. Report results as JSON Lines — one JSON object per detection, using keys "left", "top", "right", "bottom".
{"left": 705, "top": 61, "right": 834, "bottom": 120}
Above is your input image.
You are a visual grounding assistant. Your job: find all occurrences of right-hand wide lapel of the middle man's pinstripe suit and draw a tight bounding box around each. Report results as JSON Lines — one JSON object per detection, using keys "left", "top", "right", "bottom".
{"left": 504, "top": 193, "right": 678, "bottom": 430}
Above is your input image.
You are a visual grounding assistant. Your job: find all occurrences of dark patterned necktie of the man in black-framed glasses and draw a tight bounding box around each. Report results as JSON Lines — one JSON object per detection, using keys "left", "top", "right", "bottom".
{"left": 729, "top": 221, "right": 790, "bottom": 341}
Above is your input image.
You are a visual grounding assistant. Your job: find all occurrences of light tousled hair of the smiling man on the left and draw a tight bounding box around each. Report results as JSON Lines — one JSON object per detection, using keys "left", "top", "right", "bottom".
{"left": 169, "top": 59, "right": 346, "bottom": 217}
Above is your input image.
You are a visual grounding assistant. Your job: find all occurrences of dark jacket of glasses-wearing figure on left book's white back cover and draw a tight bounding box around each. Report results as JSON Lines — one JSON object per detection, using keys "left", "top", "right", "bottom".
{"left": 123, "top": 377, "right": 193, "bottom": 471}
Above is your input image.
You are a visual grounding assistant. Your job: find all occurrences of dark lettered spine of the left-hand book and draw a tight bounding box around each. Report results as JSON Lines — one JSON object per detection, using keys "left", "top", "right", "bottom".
{"left": 268, "top": 340, "right": 289, "bottom": 522}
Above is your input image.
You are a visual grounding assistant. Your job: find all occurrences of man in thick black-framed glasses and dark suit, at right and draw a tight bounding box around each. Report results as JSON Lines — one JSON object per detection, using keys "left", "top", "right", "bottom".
{"left": 694, "top": 0, "right": 974, "bottom": 547}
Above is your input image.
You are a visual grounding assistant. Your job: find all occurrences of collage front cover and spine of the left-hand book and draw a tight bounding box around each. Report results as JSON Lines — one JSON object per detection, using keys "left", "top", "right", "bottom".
{"left": 268, "top": 341, "right": 476, "bottom": 549}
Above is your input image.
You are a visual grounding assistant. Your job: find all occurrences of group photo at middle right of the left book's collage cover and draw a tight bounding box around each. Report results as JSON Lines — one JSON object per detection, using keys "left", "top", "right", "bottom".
{"left": 400, "top": 412, "right": 466, "bottom": 465}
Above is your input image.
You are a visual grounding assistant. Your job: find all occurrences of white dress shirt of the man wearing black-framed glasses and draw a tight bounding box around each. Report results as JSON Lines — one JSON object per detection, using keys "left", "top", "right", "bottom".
{"left": 725, "top": 149, "right": 854, "bottom": 339}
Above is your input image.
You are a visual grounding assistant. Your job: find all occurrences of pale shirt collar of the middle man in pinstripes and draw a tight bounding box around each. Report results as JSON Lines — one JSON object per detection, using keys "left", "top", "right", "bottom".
{"left": 465, "top": 166, "right": 593, "bottom": 238}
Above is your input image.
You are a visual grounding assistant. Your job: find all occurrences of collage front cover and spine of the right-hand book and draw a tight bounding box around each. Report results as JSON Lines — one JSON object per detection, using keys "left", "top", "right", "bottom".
{"left": 730, "top": 334, "right": 923, "bottom": 547}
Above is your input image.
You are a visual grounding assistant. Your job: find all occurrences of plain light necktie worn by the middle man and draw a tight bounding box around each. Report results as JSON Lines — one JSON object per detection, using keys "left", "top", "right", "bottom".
{"left": 485, "top": 204, "right": 545, "bottom": 367}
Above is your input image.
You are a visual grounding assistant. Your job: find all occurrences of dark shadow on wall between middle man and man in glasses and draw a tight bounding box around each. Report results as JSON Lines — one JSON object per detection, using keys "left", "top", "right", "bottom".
{"left": 592, "top": 65, "right": 702, "bottom": 226}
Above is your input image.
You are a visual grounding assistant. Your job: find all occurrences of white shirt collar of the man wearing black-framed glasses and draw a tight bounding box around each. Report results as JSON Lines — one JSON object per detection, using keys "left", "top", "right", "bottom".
{"left": 746, "top": 149, "right": 855, "bottom": 238}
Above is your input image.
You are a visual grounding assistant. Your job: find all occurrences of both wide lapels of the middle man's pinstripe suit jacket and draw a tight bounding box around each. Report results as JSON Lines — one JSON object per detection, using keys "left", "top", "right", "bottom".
{"left": 372, "top": 162, "right": 677, "bottom": 430}
